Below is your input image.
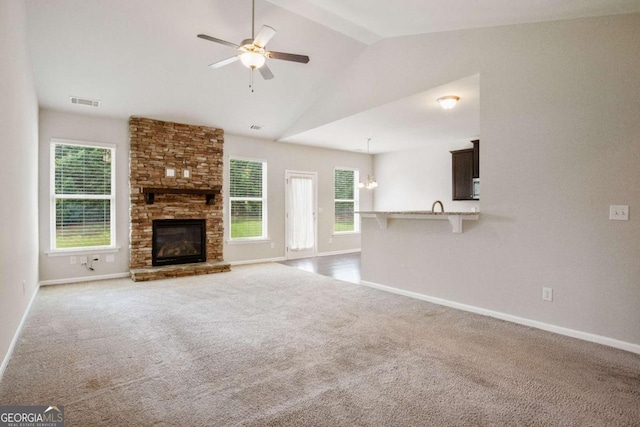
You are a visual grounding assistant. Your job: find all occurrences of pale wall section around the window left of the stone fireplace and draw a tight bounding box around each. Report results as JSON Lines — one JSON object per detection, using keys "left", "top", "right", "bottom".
{"left": 39, "top": 110, "right": 129, "bottom": 284}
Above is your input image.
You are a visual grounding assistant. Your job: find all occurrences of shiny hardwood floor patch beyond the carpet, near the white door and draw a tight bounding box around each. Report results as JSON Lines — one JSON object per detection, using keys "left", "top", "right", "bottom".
{"left": 280, "top": 252, "right": 360, "bottom": 283}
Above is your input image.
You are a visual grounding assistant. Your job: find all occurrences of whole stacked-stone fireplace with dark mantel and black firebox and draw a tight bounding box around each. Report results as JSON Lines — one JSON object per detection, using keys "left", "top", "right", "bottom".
{"left": 129, "top": 117, "right": 230, "bottom": 281}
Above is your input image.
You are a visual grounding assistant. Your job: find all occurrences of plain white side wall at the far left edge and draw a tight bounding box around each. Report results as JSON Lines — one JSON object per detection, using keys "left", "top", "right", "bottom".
{"left": 0, "top": 1, "right": 38, "bottom": 376}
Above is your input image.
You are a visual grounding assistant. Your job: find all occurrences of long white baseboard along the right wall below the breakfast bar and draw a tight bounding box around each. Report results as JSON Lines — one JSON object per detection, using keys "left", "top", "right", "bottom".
{"left": 360, "top": 280, "right": 640, "bottom": 354}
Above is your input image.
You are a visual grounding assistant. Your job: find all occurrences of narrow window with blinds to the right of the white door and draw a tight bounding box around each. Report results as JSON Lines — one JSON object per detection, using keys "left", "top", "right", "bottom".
{"left": 333, "top": 169, "right": 360, "bottom": 233}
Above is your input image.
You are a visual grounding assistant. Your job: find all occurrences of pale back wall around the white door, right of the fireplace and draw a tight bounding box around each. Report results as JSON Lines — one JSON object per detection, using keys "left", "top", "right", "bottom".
{"left": 224, "top": 135, "right": 373, "bottom": 262}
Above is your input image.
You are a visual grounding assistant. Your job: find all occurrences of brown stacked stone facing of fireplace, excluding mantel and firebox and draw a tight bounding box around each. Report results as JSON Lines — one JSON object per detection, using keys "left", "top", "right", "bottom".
{"left": 129, "top": 117, "right": 229, "bottom": 280}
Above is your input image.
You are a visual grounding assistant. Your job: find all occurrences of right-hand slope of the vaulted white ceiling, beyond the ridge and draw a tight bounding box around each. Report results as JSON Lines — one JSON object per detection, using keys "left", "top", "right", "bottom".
{"left": 267, "top": 0, "right": 640, "bottom": 43}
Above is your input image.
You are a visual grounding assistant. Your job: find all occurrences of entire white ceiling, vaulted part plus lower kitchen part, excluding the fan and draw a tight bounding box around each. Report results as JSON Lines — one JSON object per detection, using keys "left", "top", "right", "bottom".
{"left": 27, "top": 0, "right": 640, "bottom": 153}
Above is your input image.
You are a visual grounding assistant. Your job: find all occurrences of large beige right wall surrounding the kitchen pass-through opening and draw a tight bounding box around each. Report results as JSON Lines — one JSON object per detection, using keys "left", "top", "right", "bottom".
{"left": 324, "top": 14, "right": 640, "bottom": 344}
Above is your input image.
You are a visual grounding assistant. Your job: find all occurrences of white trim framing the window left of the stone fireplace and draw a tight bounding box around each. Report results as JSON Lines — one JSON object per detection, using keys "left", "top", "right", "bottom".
{"left": 48, "top": 138, "right": 119, "bottom": 254}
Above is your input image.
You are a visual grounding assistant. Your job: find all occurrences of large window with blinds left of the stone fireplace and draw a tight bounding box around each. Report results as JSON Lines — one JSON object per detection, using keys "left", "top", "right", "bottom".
{"left": 51, "top": 140, "right": 115, "bottom": 250}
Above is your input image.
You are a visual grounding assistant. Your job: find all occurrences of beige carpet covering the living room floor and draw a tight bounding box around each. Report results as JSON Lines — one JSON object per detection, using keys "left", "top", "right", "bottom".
{"left": 0, "top": 264, "right": 640, "bottom": 427}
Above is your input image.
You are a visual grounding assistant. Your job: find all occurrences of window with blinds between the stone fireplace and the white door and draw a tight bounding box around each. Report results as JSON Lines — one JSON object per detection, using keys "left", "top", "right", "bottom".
{"left": 229, "top": 159, "right": 267, "bottom": 239}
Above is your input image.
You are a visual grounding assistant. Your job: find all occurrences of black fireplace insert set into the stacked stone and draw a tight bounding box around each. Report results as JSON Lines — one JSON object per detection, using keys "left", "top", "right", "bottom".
{"left": 151, "top": 219, "right": 207, "bottom": 266}
